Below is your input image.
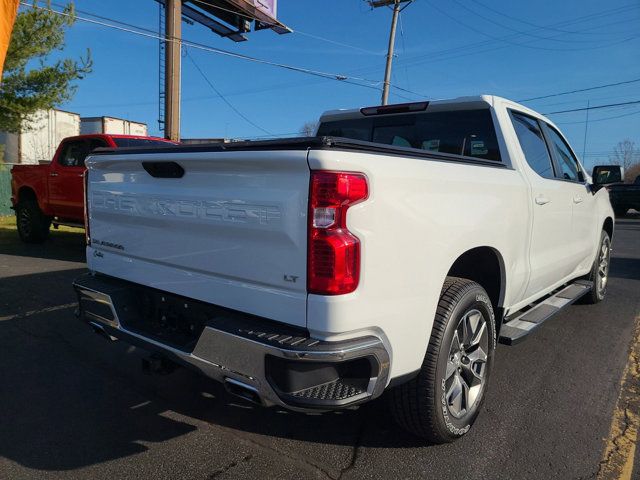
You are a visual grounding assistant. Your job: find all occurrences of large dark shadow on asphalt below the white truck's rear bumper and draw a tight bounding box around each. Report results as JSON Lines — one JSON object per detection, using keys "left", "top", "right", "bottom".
{"left": 0, "top": 269, "right": 430, "bottom": 470}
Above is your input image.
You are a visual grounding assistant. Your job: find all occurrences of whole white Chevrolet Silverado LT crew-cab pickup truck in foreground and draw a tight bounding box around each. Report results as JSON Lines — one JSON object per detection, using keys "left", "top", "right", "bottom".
{"left": 74, "top": 96, "right": 614, "bottom": 442}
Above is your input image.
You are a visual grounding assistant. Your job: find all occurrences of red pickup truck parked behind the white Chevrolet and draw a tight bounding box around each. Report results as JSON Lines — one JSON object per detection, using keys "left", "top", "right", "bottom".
{"left": 11, "top": 134, "right": 172, "bottom": 243}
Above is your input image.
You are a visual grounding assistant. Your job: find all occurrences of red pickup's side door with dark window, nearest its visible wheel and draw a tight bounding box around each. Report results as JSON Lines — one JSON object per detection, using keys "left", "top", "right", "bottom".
{"left": 49, "top": 139, "right": 89, "bottom": 222}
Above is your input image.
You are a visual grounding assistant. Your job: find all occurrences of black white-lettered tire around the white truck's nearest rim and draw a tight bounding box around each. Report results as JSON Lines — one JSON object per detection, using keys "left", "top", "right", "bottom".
{"left": 389, "top": 277, "right": 496, "bottom": 443}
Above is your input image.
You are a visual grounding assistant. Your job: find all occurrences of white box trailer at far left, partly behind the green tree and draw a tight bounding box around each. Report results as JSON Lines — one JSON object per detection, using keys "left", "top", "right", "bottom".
{"left": 0, "top": 109, "right": 80, "bottom": 164}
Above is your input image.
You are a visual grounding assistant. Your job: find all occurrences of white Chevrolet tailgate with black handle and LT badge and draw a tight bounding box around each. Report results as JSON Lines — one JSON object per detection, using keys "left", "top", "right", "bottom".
{"left": 87, "top": 149, "right": 309, "bottom": 326}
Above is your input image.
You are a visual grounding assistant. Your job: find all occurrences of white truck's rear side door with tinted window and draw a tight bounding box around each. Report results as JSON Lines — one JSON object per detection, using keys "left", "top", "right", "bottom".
{"left": 511, "top": 111, "right": 574, "bottom": 298}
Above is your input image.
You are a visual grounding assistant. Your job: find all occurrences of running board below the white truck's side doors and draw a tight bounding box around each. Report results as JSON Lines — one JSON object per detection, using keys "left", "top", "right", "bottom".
{"left": 499, "top": 280, "right": 593, "bottom": 345}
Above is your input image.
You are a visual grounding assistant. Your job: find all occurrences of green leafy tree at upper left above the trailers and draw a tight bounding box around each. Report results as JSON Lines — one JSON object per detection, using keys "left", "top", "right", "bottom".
{"left": 0, "top": 1, "right": 92, "bottom": 132}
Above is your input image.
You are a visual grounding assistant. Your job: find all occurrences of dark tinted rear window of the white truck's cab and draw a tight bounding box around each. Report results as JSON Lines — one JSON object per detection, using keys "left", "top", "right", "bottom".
{"left": 318, "top": 109, "right": 500, "bottom": 161}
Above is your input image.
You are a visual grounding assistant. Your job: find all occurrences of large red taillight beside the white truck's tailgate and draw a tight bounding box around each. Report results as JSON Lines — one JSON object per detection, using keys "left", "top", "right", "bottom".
{"left": 307, "top": 171, "right": 368, "bottom": 295}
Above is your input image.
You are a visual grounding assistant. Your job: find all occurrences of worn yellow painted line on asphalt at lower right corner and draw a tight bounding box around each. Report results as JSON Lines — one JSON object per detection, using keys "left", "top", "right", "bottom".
{"left": 597, "top": 316, "right": 640, "bottom": 480}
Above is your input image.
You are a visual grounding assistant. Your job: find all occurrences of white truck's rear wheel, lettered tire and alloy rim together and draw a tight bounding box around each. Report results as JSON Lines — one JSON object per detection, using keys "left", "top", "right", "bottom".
{"left": 390, "top": 277, "right": 496, "bottom": 443}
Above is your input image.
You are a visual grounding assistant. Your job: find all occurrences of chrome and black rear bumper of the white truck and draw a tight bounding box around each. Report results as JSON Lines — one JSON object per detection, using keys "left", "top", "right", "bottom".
{"left": 74, "top": 274, "right": 389, "bottom": 411}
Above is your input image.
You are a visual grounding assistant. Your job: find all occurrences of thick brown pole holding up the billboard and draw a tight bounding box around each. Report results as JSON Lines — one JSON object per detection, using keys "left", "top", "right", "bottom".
{"left": 164, "top": 0, "right": 182, "bottom": 142}
